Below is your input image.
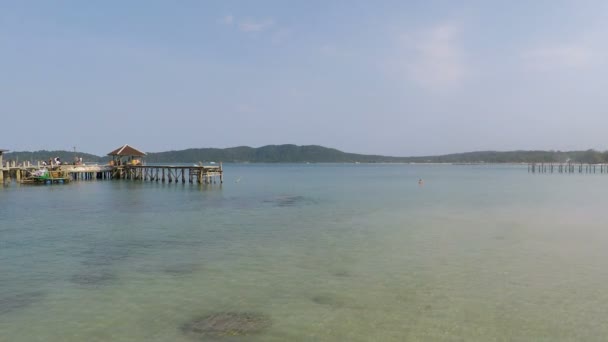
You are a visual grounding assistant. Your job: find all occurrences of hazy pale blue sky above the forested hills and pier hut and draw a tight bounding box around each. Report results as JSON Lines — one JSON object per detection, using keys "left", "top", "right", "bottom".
{"left": 0, "top": 0, "right": 608, "bottom": 156}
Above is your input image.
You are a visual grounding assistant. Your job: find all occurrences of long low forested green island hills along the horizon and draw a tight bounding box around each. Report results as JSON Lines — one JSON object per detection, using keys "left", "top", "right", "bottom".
{"left": 4, "top": 145, "right": 608, "bottom": 163}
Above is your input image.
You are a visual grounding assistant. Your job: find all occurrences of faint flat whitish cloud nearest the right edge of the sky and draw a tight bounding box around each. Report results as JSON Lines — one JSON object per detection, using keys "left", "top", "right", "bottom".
{"left": 522, "top": 44, "right": 597, "bottom": 71}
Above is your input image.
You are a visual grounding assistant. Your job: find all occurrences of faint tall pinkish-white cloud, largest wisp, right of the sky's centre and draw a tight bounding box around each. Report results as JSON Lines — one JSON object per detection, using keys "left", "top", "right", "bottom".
{"left": 390, "top": 24, "right": 469, "bottom": 89}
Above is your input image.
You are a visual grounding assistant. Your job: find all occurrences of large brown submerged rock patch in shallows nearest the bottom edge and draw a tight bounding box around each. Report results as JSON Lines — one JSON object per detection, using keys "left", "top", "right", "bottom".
{"left": 181, "top": 312, "right": 272, "bottom": 337}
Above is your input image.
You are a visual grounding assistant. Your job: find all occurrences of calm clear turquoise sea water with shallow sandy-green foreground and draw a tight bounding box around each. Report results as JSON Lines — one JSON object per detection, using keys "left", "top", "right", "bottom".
{"left": 0, "top": 164, "right": 608, "bottom": 342}
